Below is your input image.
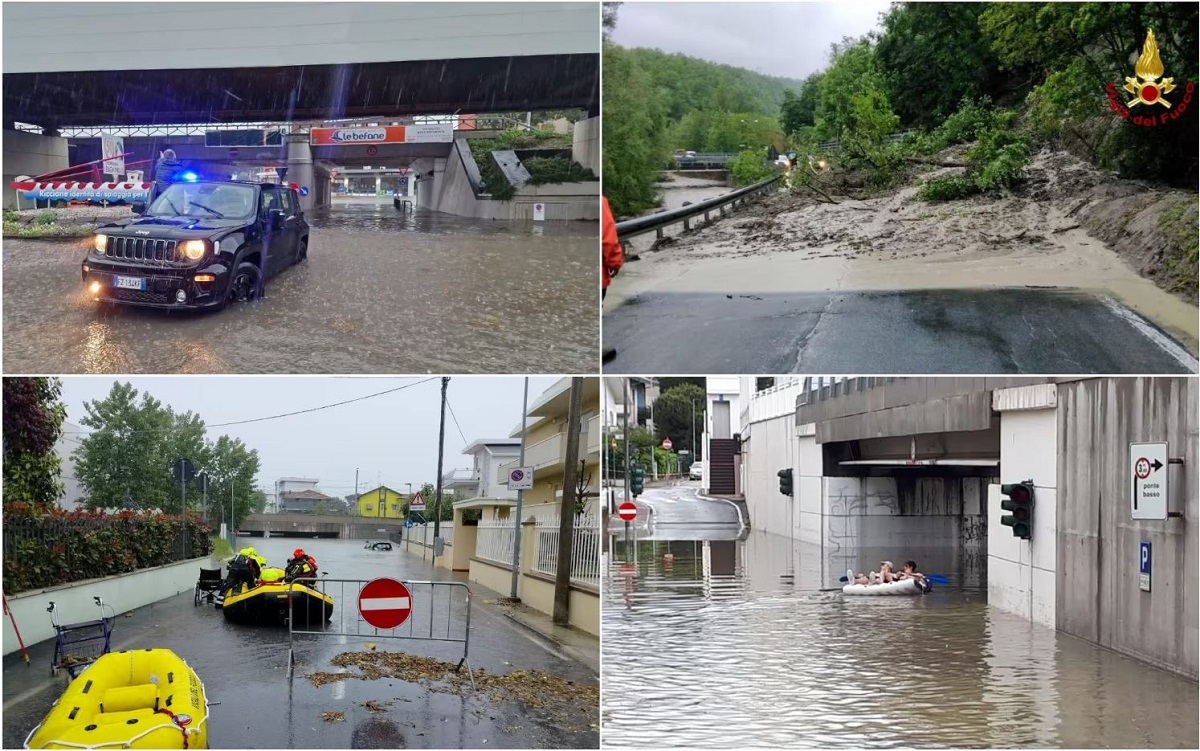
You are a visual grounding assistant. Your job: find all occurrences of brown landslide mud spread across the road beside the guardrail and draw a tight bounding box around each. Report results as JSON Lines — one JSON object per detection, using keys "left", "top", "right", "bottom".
{"left": 608, "top": 179, "right": 1200, "bottom": 353}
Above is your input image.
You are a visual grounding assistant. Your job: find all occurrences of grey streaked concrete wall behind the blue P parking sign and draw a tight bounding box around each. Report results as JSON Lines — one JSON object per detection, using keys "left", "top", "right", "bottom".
{"left": 1056, "top": 378, "right": 1200, "bottom": 680}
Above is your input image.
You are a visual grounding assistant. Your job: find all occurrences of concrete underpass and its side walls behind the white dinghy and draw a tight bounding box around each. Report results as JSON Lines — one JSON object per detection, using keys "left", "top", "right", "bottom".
{"left": 746, "top": 377, "right": 1200, "bottom": 679}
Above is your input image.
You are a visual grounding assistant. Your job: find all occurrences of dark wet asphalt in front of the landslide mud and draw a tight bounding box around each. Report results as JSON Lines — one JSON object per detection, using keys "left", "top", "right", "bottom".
{"left": 604, "top": 288, "right": 1196, "bottom": 376}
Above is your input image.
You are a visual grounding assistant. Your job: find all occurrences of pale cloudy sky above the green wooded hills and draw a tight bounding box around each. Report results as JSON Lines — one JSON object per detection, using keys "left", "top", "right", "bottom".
{"left": 612, "top": 0, "right": 892, "bottom": 78}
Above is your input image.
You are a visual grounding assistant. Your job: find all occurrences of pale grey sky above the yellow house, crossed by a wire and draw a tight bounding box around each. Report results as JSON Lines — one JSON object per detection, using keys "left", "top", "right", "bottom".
{"left": 62, "top": 377, "right": 557, "bottom": 497}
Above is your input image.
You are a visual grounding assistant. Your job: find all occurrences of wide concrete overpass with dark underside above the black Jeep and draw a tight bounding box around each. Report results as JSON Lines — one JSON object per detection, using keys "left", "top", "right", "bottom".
{"left": 4, "top": 2, "right": 600, "bottom": 209}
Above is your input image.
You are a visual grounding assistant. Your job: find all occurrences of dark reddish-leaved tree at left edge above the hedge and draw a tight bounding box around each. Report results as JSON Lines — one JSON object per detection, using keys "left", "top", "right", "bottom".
{"left": 4, "top": 378, "right": 66, "bottom": 506}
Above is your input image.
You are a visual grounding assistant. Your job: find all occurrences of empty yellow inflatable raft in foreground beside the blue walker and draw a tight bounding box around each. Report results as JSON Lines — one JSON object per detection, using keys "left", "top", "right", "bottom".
{"left": 25, "top": 649, "right": 209, "bottom": 749}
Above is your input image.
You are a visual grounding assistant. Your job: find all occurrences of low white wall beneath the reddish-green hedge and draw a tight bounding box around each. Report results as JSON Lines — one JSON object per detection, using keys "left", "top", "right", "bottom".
{"left": 4, "top": 558, "right": 209, "bottom": 655}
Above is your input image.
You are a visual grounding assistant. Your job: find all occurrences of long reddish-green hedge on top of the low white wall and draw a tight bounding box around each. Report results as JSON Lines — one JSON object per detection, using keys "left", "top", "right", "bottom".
{"left": 4, "top": 501, "right": 212, "bottom": 594}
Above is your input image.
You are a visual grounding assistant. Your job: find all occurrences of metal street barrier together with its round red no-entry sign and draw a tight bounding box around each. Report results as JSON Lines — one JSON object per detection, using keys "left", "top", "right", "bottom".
{"left": 288, "top": 578, "right": 475, "bottom": 690}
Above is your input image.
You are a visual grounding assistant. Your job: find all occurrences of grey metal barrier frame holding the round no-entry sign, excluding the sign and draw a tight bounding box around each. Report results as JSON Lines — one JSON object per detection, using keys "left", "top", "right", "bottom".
{"left": 288, "top": 578, "right": 475, "bottom": 690}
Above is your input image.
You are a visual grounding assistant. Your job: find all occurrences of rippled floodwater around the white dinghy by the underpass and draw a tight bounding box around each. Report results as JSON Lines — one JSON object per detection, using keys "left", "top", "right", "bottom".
{"left": 601, "top": 525, "right": 1198, "bottom": 749}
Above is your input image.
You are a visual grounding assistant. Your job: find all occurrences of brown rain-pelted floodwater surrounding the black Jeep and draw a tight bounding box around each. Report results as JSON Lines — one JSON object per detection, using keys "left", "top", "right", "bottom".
{"left": 4, "top": 203, "right": 600, "bottom": 373}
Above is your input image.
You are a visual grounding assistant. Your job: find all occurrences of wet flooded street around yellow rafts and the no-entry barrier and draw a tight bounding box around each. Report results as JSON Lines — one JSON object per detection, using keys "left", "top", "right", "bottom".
{"left": 4, "top": 539, "right": 599, "bottom": 749}
